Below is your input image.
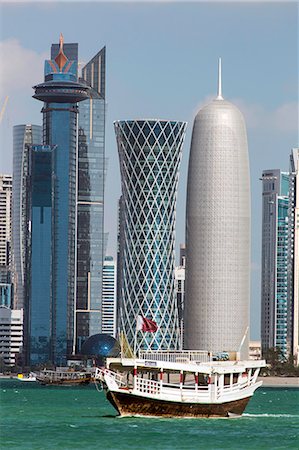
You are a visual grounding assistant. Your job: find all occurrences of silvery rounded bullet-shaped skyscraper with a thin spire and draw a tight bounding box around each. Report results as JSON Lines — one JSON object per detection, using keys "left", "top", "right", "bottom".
{"left": 184, "top": 61, "right": 250, "bottom": 357}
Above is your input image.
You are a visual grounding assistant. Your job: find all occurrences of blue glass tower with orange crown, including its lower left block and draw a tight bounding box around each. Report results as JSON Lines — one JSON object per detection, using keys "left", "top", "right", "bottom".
{"left": 26, "top": 35, "right": 90, "bottom": 365}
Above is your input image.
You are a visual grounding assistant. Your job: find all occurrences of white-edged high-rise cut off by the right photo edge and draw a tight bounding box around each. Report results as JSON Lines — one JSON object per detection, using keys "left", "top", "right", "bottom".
{"left": 287, "top": 148, "right": 299, "bottom": 365}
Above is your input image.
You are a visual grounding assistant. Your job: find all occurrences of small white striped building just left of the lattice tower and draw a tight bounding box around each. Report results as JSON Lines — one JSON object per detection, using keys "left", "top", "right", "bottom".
{"left": 101, "top": 256, "right": 116, "bottom": 337}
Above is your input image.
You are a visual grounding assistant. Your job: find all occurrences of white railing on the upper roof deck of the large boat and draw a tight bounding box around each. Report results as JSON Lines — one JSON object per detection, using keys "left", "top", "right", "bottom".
{"left": 139, "top": 350, "right": 212, "bottom": 364}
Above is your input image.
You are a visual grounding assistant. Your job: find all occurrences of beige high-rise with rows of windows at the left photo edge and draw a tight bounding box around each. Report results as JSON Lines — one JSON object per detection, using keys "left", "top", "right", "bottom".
{"left": 0, "top": 174, "right": 12, "bottom": 268}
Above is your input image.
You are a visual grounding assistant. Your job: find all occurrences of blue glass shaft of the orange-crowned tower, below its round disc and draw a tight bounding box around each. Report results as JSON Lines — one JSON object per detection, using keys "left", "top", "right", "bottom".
{"left": 46, "top": 103, "right": 77, "bottom": 361}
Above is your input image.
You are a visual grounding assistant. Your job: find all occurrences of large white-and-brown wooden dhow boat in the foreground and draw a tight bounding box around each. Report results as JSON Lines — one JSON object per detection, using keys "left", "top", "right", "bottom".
{"left": 95, "top": 350, "right": 265, "bottom": 418}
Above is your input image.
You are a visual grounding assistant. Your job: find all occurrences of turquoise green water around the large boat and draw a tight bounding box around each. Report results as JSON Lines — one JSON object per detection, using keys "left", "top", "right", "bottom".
{"left": 0, "top": 380, "right": 299, "bottom": 450}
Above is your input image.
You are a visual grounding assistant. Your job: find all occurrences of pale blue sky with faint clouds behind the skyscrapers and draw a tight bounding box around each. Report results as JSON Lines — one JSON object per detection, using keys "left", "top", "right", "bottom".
{"left": 0, "top": 0, "right": 299, "bottom": 339}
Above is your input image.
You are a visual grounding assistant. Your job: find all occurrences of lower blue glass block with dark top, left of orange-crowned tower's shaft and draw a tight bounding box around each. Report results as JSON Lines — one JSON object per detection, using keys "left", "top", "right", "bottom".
{"left": 28, "top": 146, "right": 55, "bottom": 364}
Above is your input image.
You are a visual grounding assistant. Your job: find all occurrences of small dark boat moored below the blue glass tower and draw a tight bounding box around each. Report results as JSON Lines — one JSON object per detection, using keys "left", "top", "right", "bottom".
{"left": 36, "top": 369, "right": 94, "bottom": 386}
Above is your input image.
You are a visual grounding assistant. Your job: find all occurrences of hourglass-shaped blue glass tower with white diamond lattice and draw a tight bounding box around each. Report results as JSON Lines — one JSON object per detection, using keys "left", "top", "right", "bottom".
{"left": 114, "top": 120, "right": 186, "bottom": 351}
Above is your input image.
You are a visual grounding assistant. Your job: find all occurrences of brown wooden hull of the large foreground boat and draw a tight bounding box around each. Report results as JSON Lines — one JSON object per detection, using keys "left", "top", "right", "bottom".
{"left": 107, "top": 390, "right": 250, "bottom": 418}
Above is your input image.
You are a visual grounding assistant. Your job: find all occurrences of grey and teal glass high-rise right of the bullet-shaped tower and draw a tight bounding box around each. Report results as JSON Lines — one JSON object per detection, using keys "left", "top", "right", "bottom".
{"left": 261, "top": 170, "right": 289, "bottom": 356}
